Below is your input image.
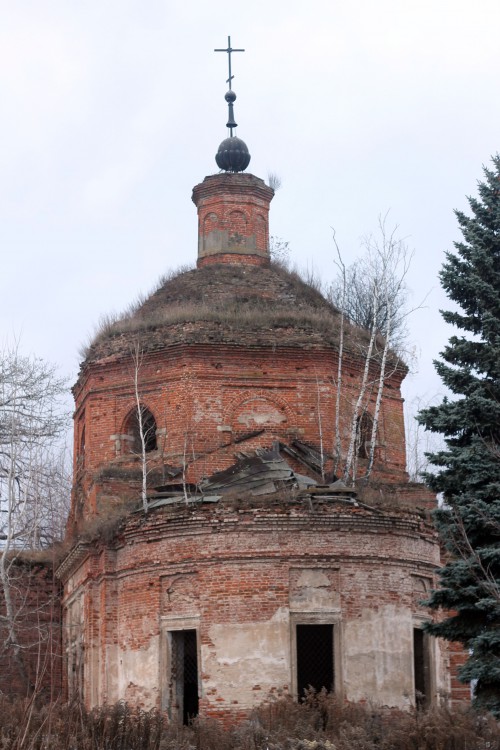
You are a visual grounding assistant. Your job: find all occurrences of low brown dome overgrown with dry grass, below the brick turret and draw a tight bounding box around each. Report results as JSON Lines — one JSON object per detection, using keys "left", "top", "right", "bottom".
{"left": 78, "top": 263, "right": 365, "bottom": 370}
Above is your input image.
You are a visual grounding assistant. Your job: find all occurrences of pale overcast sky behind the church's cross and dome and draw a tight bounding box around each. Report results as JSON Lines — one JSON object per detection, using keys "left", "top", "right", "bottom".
{"left": 0, "top": 0, "right": 500, "bottom": 428}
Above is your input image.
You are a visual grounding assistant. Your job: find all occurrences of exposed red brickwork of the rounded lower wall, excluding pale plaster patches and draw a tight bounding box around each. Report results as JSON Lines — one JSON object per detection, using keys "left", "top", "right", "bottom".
{"left": 59, "top": 499, "right": 439, "bottom": 715}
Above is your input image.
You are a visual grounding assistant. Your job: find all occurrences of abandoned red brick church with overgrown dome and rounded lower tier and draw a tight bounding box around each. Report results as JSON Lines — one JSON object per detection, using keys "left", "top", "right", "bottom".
{"left": 51, "top": 47, "right": 468, "bottom": 721}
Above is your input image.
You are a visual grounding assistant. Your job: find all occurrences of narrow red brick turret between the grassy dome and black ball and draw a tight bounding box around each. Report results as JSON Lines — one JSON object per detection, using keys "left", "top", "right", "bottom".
{"left": 193, "top": 173, "right": 274, "bottom": 267}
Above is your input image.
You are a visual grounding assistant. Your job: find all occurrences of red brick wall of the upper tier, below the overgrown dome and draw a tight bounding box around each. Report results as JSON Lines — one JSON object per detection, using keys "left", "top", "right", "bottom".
{"left": 73, "top": 345, "right": 406, "bottom": 516}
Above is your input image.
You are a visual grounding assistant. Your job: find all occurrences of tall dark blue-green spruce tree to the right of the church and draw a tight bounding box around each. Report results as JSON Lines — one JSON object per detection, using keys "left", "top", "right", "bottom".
{"left": 419, "top": 154, "right": 500, "bottom": 717}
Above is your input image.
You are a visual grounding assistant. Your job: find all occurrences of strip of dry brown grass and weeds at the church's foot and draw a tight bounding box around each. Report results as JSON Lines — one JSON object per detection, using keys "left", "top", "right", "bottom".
{"left": 0, "top": 693, "right": 500, "bottom": 750}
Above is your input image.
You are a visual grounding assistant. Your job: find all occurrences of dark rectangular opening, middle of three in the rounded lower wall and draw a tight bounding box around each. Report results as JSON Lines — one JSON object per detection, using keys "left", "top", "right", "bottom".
{"left": 297, "top": 625, "right": 334, "bottom": 700}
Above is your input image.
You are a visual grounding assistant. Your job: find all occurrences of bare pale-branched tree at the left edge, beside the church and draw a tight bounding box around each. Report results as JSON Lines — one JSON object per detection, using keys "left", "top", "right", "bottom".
{"left": 0, "top": 345, "right": 67, "bottom": 688}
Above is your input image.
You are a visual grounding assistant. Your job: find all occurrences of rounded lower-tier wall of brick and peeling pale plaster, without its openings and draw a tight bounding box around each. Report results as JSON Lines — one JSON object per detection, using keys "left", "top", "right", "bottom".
{"left": 60, "top": 498, "right": 447, "bottom": 714}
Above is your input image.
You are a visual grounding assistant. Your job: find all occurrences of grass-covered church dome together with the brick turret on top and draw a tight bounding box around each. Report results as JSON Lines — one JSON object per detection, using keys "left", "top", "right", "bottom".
{"left": 82, "top": 172, "right": 378, "bottom": 382}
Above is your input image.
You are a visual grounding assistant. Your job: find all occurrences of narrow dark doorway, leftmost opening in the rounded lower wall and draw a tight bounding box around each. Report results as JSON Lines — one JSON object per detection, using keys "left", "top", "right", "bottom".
{"left": 170, "top": 630, "right": 198, "bottom": 725}
